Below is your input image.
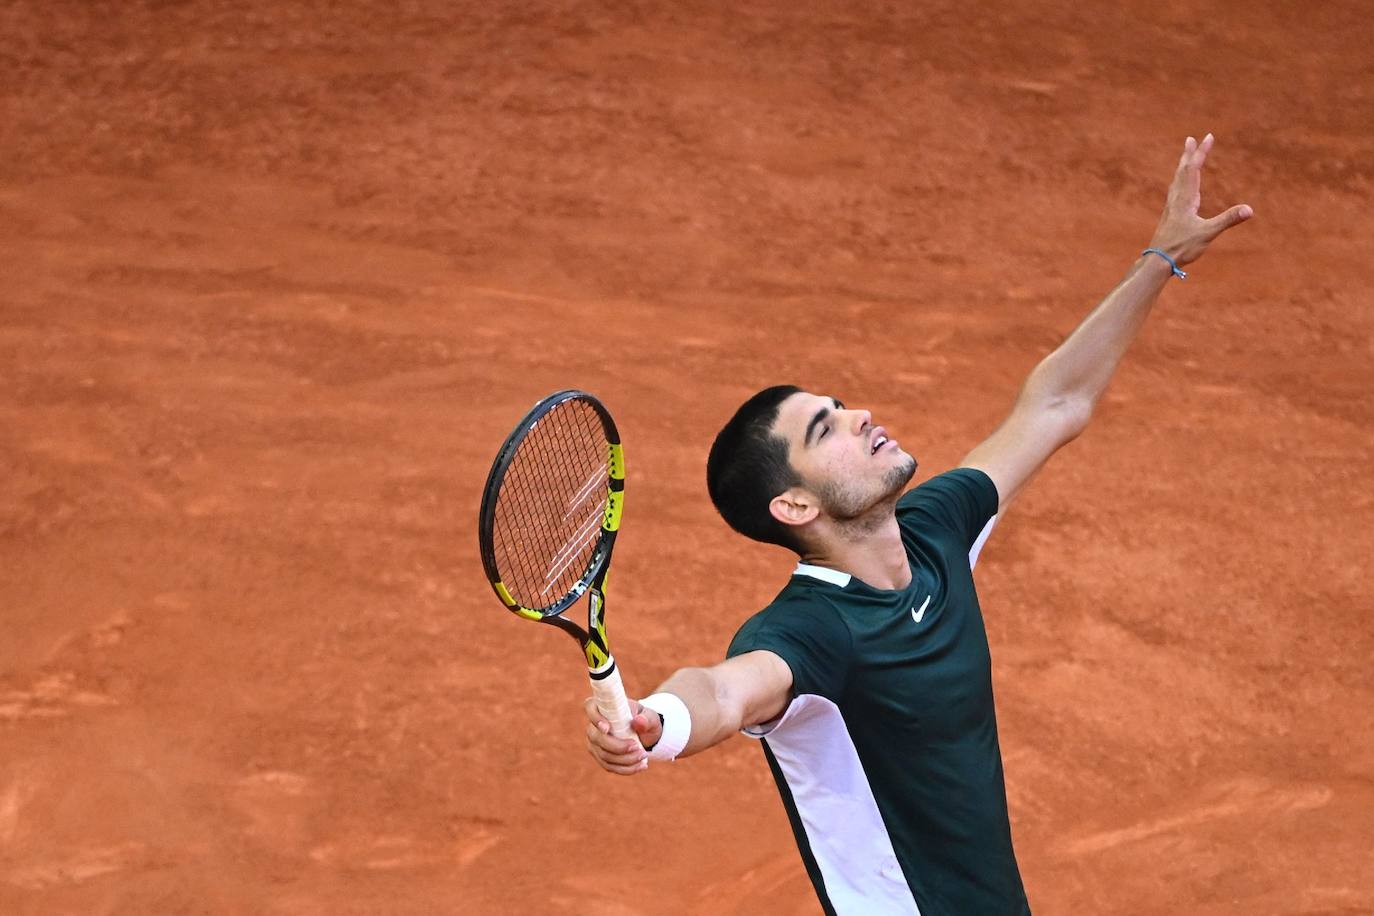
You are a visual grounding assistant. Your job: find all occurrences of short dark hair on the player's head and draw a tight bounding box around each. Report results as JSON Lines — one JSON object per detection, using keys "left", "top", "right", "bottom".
{"left": 706, "top": 385, "right": 802, "bottom": 553}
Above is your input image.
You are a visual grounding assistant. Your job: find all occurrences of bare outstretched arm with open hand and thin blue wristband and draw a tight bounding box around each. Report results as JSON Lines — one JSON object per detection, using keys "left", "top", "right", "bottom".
{"left": 963, "top": 133, "right": 1253, "bottom": 511}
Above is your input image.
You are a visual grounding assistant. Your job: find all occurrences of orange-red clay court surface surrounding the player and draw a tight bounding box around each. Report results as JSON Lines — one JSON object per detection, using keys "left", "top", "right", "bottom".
{"left": 0, "top": 0, "right": 1374, "bottom": 916}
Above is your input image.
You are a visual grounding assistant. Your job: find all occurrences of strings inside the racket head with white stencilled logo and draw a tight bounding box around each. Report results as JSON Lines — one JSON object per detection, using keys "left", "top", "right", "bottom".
{"left": 492, "top": 400, "right": 609, "bottom": 608}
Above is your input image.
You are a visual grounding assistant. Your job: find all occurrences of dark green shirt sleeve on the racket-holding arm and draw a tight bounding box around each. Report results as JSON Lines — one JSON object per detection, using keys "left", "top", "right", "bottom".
{"left": 725, "top": 602, "right": 853, "bottom": 703}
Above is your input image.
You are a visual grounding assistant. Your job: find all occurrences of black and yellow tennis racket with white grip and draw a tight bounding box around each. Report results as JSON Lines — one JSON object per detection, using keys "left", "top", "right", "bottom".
{"left": 477, "top": 389, "right": 635, "bottom": 737}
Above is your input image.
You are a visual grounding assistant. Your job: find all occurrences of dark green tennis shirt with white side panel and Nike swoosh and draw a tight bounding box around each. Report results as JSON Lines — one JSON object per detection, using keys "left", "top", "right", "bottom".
{"left": 727, "top": 468, "right": 1031, "bottom": 916}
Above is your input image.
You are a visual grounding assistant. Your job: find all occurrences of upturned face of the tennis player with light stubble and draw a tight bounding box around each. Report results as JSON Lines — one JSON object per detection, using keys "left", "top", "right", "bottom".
{"left": 772, "top": 391, "right": 916, "bottom": 520}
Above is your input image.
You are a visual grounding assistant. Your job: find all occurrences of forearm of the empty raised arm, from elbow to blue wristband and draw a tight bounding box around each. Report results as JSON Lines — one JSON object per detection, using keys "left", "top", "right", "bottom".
{"left": 1022, "top": 254, "right": 1171, "bottom": 409}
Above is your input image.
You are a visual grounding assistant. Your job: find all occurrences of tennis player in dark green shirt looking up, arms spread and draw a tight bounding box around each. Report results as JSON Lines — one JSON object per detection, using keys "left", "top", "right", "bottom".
{"left": 585, "top": 135, "right": 1252, "bottom": 916}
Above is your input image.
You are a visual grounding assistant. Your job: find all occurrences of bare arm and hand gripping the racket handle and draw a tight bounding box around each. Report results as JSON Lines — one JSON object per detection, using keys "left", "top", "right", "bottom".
{"left": 583, "top": 650, "right": 791, "bottom": 776}
